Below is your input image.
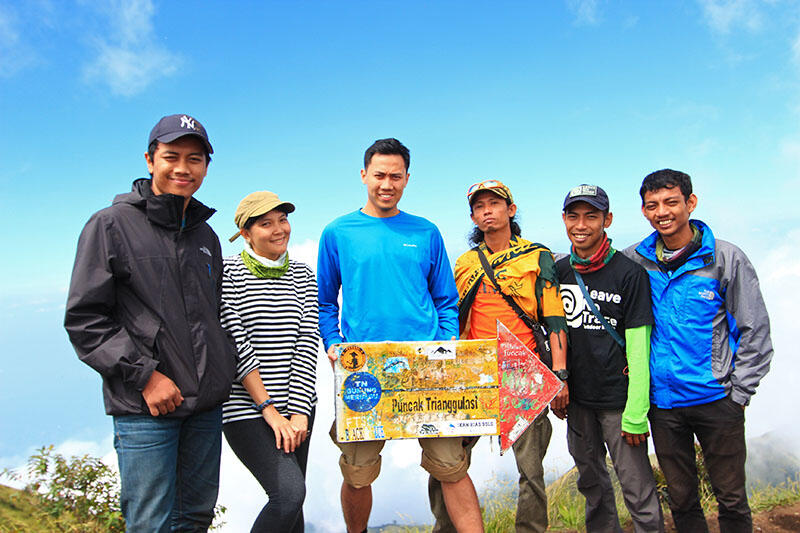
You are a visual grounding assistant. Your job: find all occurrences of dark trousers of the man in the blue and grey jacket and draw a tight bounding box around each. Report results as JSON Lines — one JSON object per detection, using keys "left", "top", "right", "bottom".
{"left": 650, "top": 397, "right": 753, "bottom": 533}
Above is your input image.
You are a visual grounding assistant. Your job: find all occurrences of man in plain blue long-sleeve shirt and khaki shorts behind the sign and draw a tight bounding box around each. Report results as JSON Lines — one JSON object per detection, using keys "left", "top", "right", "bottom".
{"left": 317, "top": 139, "right": 483, "bottom": 533}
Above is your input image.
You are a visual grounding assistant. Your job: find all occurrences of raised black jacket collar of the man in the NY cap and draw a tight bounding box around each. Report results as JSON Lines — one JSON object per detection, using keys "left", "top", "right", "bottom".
{"left": 114, "top": 178, "right": 216, "bottom": 231}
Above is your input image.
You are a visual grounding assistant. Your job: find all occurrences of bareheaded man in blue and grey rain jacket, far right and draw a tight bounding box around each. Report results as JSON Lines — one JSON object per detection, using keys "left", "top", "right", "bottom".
{"left": 625, "top": 169, "right": 772, "bottom": 533}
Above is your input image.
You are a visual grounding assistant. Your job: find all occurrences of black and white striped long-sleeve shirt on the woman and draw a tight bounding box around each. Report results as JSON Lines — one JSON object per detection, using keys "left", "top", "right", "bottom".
{"left": 221, "top": 255, "right": 319, "bottom": 422}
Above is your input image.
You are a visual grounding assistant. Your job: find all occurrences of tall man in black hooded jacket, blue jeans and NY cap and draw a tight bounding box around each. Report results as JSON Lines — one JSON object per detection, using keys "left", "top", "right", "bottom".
{"left": 64, "top": 115, "right": 237, "bottom": 532}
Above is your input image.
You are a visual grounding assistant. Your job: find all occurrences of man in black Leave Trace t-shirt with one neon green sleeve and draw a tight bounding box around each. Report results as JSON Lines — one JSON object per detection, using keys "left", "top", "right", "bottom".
{"left": 556, "top": 185, "right": 664, "bottom": 533}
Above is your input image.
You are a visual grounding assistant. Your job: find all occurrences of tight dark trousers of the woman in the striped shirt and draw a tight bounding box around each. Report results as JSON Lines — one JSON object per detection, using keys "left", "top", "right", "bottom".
{"left": 222, "top": 410, "right": 314, "bottom": 533}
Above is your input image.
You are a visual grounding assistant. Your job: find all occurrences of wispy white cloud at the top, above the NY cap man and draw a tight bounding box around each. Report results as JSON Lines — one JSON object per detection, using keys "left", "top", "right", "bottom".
{"left": 84, "top": 0, "right": 182, "bottom": 96}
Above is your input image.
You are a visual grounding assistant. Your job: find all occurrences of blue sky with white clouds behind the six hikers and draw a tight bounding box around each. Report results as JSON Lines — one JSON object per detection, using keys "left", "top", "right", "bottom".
{"left": 0, "top": 0, "right": 800, "bottom": 530}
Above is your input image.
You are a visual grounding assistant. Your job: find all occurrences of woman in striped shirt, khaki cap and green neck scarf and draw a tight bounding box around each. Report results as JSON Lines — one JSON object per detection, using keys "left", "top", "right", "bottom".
{"left": 221, "top": 191, "right": 319, "bottom": 532}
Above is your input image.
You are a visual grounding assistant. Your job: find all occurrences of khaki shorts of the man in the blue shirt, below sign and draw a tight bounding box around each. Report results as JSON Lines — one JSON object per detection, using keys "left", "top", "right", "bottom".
{"left": 330, "top": 422, "right": 469, "bottom": 489}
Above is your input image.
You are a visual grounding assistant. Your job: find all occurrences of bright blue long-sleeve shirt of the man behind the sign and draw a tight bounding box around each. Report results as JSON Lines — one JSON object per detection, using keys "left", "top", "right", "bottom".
{"left": 317, "top": 210, "right": 458, "bottom": 350}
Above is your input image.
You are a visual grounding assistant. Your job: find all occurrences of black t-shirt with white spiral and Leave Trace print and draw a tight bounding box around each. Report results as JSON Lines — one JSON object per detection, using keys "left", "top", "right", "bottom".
{"left": 556, "top": 252, "right": 653, "bottom": 409}
